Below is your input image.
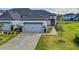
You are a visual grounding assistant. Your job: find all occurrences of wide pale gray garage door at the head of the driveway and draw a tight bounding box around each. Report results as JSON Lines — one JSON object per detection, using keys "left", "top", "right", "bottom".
{"left": 23, "top": 23, "right": 43, "bottom": 32}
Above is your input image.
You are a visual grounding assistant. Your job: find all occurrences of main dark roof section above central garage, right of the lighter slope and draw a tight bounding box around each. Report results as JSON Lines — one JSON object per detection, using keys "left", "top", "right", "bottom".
{"left": 9, "top": 8, "right": 55, "bottom": 18}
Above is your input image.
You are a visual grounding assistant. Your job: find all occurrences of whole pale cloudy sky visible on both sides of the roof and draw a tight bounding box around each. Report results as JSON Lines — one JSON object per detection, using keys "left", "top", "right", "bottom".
{"left": 0, "top": 8, "right": 79, "bottom": 14}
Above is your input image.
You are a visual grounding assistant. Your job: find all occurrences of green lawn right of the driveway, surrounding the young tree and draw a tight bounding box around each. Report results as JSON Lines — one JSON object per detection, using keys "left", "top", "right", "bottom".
{"left": 36, "top": 22, "right": 79, "bottom": 50}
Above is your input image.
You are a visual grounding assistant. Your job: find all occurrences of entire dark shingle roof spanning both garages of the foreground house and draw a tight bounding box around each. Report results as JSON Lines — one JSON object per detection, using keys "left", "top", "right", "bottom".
{"left": 0, "top": 8, "right": 55, "bottom": 19}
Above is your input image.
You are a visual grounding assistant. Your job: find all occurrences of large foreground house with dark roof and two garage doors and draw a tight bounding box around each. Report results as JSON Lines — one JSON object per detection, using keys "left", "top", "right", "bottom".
{"left": 0, "top": 8, "right": 56, "bottom": 32}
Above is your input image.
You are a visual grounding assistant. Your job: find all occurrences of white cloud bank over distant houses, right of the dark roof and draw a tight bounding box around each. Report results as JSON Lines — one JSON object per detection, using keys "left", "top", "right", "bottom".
{"left": 45, "top": 8, "right": 79, "bottom": 14}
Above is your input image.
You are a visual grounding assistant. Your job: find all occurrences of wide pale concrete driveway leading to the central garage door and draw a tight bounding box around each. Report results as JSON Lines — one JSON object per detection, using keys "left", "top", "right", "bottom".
{"left": 0, "top": 33, "right": 41, "bottom": 50}
